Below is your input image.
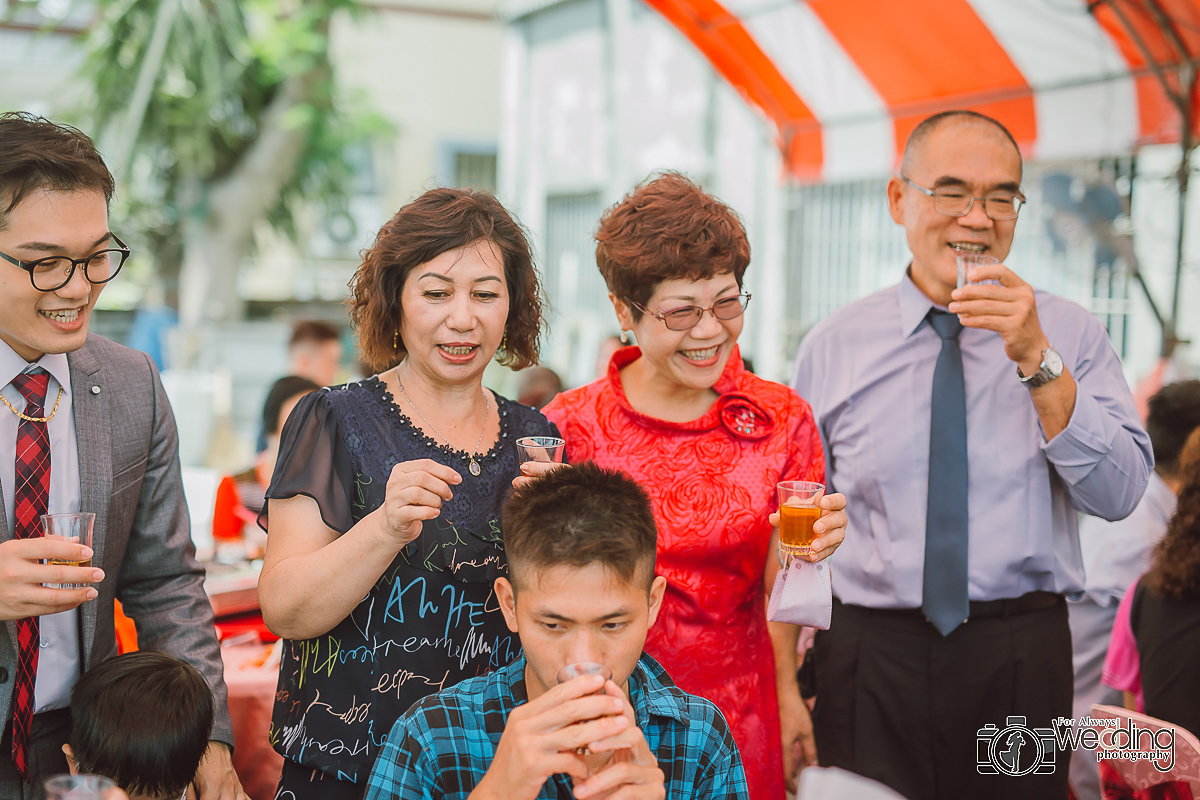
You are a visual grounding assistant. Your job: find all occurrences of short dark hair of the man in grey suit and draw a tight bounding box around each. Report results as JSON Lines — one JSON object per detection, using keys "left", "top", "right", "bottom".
{"left": 0, "top": 112, "right": 115, "bottom": 230}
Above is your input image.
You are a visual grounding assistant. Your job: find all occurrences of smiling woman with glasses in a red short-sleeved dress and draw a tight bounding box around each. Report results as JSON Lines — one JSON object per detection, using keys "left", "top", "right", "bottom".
{"left": 542, "top": 174, "right": 846, "bottom": 800}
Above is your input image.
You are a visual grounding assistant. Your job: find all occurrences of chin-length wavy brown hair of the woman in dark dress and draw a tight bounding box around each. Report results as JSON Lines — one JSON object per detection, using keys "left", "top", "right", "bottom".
{"left": 347, "top": 188, "right": 542, "bottom": 372}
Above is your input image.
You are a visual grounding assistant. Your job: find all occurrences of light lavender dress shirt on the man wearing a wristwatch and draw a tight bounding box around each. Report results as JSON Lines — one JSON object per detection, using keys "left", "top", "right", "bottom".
{"left": 792, "top": 273, "right": 1153, "bottom": 608}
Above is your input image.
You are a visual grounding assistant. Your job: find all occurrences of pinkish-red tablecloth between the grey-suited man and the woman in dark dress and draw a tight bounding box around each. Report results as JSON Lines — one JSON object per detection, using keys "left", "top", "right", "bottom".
{"left": 221, "top": 644, "right": 283, "bottom": 800}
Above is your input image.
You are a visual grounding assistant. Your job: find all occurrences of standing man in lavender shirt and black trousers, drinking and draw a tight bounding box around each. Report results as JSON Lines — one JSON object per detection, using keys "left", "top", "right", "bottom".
{"left": 793, "top": 112, "right": 1153, "bottom": 798}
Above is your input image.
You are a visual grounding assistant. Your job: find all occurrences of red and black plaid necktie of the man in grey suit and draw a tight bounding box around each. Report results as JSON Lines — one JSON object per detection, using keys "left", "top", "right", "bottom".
{"left": 12, "top": 368, "right": 50, "bottom": 781}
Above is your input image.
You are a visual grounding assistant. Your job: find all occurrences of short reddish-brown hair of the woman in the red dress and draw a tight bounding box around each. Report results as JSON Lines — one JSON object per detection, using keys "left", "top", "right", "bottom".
{"left": 596, "top": 173, "right": 750, "bottom": 319}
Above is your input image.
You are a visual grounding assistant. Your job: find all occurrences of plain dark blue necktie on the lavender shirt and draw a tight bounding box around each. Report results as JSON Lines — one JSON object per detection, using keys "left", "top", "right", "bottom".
{"left": 920, "top": 308, "right": 971, "bottom": 636}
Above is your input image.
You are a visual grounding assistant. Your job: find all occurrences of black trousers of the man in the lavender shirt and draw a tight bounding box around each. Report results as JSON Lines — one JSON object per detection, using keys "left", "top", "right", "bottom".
{"left": 812, "top": 593, "right": 1074, "bottom": 800}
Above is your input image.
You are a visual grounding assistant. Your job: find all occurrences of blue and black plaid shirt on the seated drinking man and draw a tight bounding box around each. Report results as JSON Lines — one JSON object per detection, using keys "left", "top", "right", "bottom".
{"left": 366, "top": 652, "right": 750, "bottom": 800}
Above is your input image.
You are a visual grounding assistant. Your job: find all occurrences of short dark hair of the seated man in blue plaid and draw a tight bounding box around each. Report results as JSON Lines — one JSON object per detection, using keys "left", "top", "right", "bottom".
{"left": 500, "top": 462, "right": 658, "bottom": 589}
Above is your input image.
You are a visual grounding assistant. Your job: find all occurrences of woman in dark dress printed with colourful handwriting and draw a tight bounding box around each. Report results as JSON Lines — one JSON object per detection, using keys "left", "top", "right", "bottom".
{"left": 258, "top": 190, "right": 558, "bottom": 800}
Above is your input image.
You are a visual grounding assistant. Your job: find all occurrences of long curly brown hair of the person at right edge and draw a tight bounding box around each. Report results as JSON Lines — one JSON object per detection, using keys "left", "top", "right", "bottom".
{"left": 1145, "top": 428, "right": 1200, "bottom": 600}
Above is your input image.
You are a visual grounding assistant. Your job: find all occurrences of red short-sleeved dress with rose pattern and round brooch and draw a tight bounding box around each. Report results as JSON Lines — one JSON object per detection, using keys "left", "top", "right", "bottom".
{"left": 542, "top": 347, "right": 824, "bottom": 800}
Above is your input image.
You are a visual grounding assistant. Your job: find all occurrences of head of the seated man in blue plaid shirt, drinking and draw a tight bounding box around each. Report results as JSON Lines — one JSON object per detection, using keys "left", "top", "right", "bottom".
{"left": 496, "top": 463, "right": 666, "bottom": 698}
